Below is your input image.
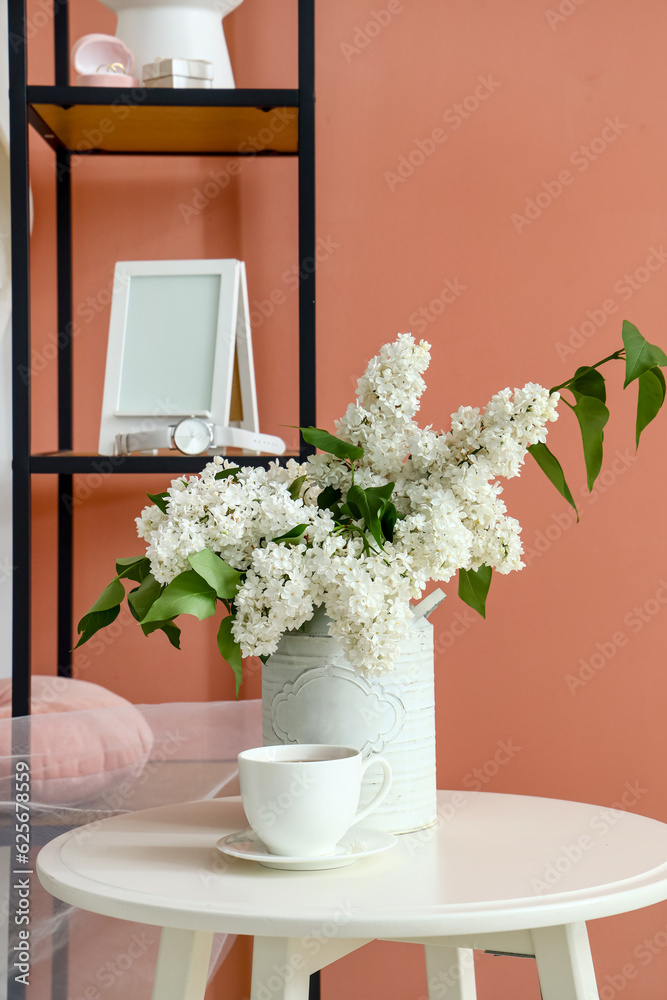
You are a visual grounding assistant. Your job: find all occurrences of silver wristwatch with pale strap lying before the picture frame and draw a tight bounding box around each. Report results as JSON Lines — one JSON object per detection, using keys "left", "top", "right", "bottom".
{"left": 115, "top": 417, "right": 285, "bottom": 455}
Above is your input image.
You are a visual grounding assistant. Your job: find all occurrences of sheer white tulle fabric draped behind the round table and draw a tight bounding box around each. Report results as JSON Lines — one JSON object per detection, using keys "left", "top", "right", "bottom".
{"left": 0, "top": 701, "right": 262, "bottom": 1000}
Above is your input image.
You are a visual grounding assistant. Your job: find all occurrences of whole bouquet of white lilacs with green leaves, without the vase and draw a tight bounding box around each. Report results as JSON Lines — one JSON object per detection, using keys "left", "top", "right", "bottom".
{"left": 78, "top": 323, "right": 667, "bottom": 690}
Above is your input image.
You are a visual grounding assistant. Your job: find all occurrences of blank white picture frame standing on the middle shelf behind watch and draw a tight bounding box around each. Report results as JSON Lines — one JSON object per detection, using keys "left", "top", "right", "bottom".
{"left": 99, "top": 259, "right": 259, "bottom": 455}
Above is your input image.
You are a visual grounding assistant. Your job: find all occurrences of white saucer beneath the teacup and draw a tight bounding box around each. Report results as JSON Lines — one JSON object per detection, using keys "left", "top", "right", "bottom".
{"left": 215, "top": 826, "right": 396, "bottom": 872}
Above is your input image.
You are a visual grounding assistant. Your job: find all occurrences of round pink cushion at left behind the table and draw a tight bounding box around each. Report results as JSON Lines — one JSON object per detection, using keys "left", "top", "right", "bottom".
{"left": 0, "top": 676, "right": 153, "bottom": 805}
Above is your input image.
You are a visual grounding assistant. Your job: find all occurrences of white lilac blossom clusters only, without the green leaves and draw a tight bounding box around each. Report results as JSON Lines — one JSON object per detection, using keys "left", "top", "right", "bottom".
{"left": 137, "top": 334, "right": 559, "bottom": 674}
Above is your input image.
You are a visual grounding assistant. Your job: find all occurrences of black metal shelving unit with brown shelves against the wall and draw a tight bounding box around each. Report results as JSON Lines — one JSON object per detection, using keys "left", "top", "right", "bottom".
{"left": 8, "top": 0, "right": 316, "bottom": 716}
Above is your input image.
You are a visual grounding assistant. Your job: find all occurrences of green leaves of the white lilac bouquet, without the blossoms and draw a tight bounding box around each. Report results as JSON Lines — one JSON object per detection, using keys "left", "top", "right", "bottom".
{"left": 77, "top": 321, "right": 667, "bottom": 696}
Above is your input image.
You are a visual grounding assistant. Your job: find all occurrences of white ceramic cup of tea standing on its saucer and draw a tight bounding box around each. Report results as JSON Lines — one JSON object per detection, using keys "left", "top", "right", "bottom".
{"left": 238, "top": 743, "right": 391, "bottom": 858}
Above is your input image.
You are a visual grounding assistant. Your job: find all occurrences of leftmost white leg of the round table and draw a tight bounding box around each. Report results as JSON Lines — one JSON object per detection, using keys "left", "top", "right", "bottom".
{"left": 153, "top": 927, "right": 213, "bottom": 1000}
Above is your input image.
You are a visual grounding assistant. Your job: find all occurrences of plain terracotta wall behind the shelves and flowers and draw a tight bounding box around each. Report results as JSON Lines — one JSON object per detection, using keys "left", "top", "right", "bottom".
{"left": 22, "top": 0, "right": 667, "bottom": 1000}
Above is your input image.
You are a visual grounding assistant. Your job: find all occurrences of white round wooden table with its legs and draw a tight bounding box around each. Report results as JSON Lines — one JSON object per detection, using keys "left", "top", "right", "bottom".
{"left": 37, "top": 792, "right": 667, "bottom": 1000}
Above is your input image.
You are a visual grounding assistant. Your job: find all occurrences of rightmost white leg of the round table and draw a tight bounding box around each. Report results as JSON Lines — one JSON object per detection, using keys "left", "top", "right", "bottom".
{"left": 531, "top": 923, "right": 599, "bottom": 1000}
